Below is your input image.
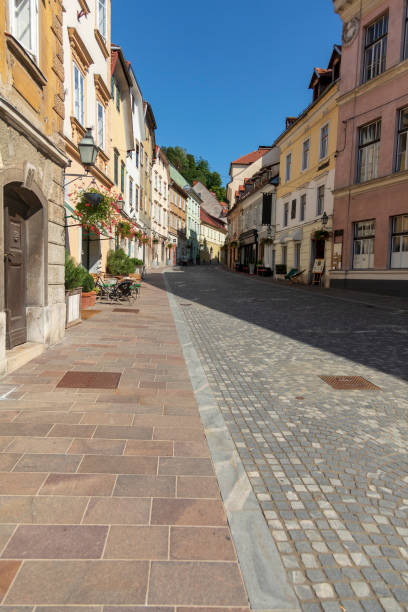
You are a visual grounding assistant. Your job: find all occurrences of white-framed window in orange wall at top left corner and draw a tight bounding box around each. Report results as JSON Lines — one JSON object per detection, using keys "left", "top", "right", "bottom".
{"left": 10, "top": 0, "right": 38, "bottom": 61}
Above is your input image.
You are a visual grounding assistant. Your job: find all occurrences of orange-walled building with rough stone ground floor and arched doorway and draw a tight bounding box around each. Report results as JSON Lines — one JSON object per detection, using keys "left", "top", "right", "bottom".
{"left": 0, "top": 0, "right": 68, "bottom": 372}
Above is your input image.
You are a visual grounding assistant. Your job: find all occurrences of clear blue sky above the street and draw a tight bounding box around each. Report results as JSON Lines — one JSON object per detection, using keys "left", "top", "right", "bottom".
{"left": 112, "top": 0, "right": 341, "bottom": 181}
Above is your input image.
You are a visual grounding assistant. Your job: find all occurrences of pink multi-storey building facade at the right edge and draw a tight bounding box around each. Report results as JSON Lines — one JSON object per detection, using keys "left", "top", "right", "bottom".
{"left": 330, "top": 0, "right": 408, "bottom": 296}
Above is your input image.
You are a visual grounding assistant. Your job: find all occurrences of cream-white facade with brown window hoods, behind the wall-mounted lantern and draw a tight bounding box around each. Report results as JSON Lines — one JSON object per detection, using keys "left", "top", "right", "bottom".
{"left": 63, "top": 0, "right": 111, "bottom": 272}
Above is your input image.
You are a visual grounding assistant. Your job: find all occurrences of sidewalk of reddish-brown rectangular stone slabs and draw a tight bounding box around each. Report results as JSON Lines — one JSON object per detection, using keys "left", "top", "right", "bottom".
{"left": 0, "top": 274, "right": 248, "bottom": 612}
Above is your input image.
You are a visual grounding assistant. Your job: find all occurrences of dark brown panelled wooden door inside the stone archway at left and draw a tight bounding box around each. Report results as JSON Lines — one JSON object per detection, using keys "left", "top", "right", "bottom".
{"left": 4, "top": 200, "right": 27, "bottom": 349}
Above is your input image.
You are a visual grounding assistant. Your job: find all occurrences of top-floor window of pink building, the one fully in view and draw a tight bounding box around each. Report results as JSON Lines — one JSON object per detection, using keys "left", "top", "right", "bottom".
{"left": 363, "top": 15, "right": 388, "bottom": 83}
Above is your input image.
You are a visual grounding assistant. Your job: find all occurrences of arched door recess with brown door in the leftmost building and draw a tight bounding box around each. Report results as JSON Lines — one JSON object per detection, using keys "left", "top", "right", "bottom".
{"left": 4, "top": 182, "right": 46, "bottom": 349}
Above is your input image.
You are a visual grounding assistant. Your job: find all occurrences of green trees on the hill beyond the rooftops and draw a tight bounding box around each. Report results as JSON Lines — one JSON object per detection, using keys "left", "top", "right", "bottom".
{"left": 162, "top": 147, "right": 226, "bottom": 202}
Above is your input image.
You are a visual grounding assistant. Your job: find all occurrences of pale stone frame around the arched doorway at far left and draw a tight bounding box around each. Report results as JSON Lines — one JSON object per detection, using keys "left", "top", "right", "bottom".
{"left": 0, "top": 166, "right": 49, "bottom": 373}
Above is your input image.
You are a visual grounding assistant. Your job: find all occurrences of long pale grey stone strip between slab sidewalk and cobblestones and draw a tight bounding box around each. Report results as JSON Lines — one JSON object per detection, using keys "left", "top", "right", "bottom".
{"left": 163, "top": 273, "right": 300, "bottom": 612}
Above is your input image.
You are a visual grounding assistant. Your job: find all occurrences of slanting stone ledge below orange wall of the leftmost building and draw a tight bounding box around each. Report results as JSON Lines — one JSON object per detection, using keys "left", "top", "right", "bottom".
{"left": 0, "top": 96, "right": 69, "bottom": 168}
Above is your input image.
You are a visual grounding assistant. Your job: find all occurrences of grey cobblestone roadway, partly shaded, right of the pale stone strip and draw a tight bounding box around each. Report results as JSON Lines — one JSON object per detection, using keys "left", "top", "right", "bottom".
{"left": 166, "top": 267, "right": 408, "bottom": 612}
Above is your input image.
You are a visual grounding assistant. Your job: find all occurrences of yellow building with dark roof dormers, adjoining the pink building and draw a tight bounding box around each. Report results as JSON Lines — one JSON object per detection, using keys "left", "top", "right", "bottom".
{"left": 273, "top": 46, "right": 341, "bottom": 285}
